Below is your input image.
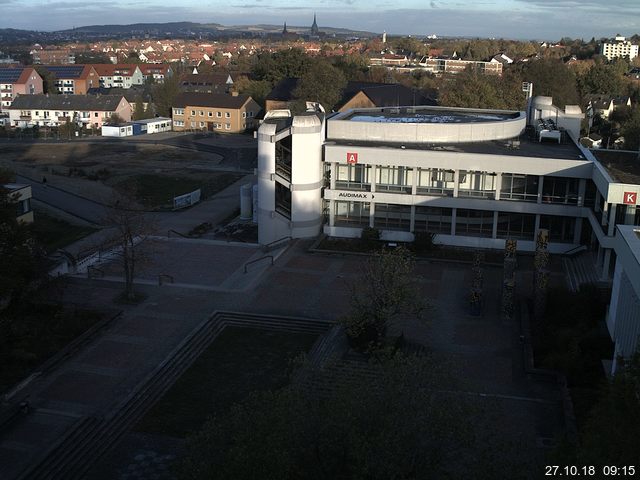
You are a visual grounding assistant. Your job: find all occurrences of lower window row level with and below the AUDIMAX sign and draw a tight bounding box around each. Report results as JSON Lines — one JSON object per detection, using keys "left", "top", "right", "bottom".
{"left": 334, "top": 201, "right": 576, "bottom": 243}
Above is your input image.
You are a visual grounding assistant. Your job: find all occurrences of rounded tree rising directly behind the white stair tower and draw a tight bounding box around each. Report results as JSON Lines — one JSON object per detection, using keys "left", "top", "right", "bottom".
{"left": 293, "top": 60, "right": 347, "bottom": 112}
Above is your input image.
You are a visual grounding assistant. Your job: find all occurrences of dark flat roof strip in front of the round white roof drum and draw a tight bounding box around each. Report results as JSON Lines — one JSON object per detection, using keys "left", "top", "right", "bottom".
{"left": 326, "top": 134, "right": 588, "bottom": 161}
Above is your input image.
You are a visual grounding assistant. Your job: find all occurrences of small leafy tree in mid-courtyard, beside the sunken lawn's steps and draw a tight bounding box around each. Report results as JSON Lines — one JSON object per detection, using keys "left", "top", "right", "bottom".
{"left": 340, "top": 247, "right": 424, "bottom": 350}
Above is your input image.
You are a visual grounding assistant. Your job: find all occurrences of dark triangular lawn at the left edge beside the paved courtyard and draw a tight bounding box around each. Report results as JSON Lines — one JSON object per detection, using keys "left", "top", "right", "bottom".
{"left": 0, "top": 305, "right": 102, "bottom": 392}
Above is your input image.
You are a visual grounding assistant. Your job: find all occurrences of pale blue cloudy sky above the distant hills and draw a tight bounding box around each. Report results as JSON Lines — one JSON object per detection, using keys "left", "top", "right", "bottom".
{"left": 0, "top": 0, "right": 640, "bottom": 40}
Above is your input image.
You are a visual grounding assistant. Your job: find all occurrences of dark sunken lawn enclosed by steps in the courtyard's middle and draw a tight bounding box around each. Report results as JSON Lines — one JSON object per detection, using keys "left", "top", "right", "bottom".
{"left": 136, "top": 327, "right": 317, "bottom": 437}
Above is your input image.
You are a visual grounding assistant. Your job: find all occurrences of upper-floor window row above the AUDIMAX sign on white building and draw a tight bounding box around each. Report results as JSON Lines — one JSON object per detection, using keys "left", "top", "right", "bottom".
{"left": 336, "top": 165, "right": 579, "bottom": 205}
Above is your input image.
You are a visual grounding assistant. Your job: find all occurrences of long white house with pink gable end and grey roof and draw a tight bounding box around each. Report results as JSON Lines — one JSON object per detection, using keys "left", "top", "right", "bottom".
{"left": 9, "top": 95, "right": 131, "bottom": 128}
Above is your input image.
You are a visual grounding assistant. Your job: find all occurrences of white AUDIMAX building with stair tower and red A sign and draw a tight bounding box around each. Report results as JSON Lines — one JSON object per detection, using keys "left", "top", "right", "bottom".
{"left": 257, "top": 97, "right": 640, "bottom": 368}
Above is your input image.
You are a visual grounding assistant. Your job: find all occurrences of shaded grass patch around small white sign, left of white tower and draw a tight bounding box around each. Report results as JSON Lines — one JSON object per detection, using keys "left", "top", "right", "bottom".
{"left": 117, "top": 172, "right": 241, "bottom": 209}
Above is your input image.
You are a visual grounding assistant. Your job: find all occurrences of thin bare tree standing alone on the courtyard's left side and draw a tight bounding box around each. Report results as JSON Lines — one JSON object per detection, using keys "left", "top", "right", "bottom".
{"left": 105, "top": 189, "right": 153, "bottom": 301}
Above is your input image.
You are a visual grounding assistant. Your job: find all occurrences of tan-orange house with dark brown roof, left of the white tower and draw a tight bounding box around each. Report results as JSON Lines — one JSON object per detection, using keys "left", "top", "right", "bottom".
{"left": 172, "top": 92, "right": 260, "bottom": 133}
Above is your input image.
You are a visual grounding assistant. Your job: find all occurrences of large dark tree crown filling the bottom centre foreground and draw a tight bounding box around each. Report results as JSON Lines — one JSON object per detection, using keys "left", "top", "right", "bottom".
{"left": 178, "top": 355, "right": 534, "bottom": 480}
